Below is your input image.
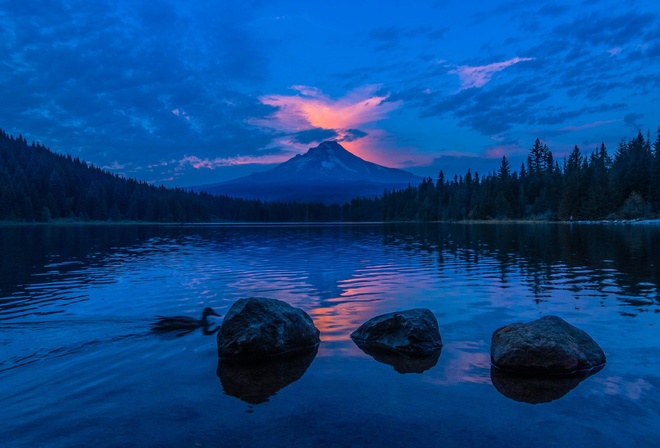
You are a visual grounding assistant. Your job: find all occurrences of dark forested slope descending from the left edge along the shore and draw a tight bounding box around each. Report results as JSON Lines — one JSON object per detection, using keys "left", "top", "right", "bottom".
{"left": 0, "top": 130, "right": 340, "bottom": 223}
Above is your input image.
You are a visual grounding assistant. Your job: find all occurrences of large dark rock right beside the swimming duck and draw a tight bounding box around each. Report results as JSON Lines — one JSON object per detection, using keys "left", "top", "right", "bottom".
{"left": 218, "top": 298, "right": 320, "bottom": 361}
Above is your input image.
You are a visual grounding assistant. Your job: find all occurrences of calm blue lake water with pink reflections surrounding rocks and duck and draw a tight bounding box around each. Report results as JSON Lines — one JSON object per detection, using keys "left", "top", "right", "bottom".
{"left": 0, "top": 224, "right": 660, "bottom": 447}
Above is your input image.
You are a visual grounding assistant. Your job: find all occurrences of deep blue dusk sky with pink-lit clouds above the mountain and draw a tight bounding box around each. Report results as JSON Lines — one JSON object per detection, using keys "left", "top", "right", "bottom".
{"left": 0, "top": 0, "right": 660, "bottom": 187}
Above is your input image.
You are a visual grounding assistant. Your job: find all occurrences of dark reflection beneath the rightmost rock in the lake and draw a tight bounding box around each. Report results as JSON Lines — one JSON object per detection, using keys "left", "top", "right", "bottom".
{"left": 490, "top": 366, "right": 602, "bottom": 404}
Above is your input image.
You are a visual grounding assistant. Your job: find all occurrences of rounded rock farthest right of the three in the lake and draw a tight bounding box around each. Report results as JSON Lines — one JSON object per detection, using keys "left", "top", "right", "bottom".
{"left": 490, "top": 316, "right": 605, "bottom": 375}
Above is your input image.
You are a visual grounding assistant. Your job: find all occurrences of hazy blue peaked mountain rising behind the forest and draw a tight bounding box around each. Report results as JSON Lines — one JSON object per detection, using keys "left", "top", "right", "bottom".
{"left": 195, "top": 141, "right": 423, "bottom": 204}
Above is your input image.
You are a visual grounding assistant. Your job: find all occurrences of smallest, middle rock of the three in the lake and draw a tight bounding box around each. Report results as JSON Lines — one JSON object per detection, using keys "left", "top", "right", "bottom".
{"left": 351, "top": 308, "right": 442, "bottom": 356}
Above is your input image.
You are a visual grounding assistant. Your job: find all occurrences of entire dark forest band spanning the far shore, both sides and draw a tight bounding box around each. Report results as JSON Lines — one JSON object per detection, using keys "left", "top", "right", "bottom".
{"left": 0, "top": 129, "right": 660, "bottom": 223}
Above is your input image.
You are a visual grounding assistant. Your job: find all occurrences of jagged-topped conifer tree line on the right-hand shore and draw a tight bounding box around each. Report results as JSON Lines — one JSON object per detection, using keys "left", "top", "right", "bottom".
{"left": 372, "top": 129, "right": 660, "bottom": 221}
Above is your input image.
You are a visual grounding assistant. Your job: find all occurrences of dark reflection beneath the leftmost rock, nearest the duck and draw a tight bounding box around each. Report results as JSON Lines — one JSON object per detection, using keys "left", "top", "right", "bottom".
{"left": 216, "top": 346, "right": 318, "bottom": 404}
